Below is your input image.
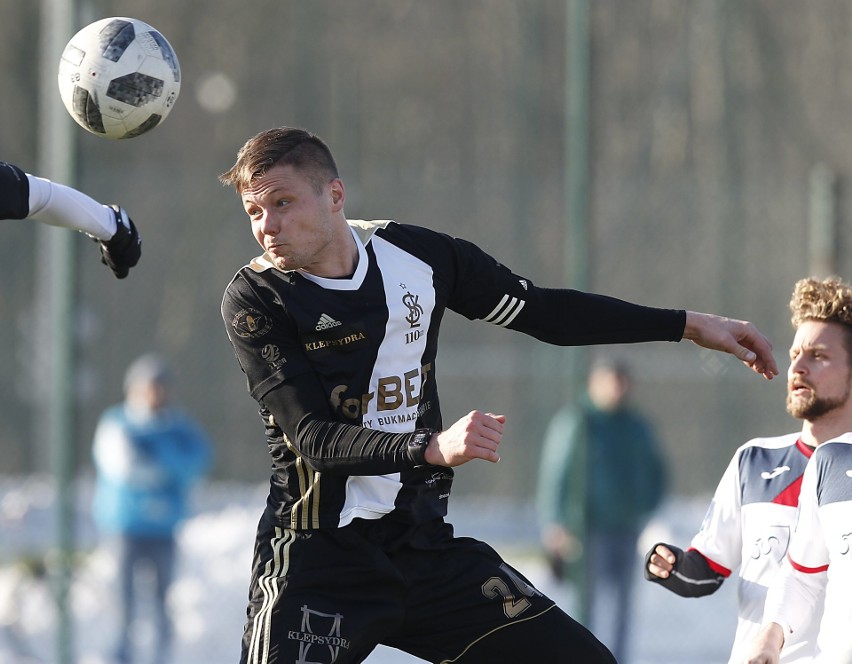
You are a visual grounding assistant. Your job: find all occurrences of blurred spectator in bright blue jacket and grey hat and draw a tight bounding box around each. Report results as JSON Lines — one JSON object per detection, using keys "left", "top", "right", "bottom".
{"left": 93, "top": 354, "right": 211, "bottom": 664}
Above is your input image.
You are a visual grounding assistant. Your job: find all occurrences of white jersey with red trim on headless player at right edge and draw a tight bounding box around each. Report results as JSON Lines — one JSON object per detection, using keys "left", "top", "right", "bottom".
{"left": 764, "top": 433, "right": 852, "bottom": 664}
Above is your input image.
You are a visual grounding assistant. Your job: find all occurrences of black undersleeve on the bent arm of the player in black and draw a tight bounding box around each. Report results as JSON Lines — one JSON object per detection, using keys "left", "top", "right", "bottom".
{"left": 262, "top": 373, "right": 432, "bottom": 475}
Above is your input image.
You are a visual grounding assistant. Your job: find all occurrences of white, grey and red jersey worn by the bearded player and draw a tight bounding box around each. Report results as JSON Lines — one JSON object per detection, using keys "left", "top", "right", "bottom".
{"left": 691, "top": 433, "right": 816, "bottom": 664}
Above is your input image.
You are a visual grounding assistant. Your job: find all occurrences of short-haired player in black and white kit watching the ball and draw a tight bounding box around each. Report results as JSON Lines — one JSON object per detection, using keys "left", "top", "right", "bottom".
{"left": 221, "top": 127, "right": 777, "bottom": 664}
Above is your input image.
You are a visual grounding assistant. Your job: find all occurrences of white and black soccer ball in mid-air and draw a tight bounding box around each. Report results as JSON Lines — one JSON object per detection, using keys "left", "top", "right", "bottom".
{"left": 59, "top": 16, "right": 180, "bottom": 138}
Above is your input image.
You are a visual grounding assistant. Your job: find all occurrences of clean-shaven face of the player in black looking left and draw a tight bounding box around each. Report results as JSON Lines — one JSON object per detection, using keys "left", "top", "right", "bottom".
{"left": 242, "top": 165, "right": 352, "bottom": 277}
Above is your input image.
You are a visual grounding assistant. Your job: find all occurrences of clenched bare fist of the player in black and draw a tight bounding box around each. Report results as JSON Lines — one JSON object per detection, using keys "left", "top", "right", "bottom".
{"left": 425, "top": 410, "right": 506, "bottom": 468}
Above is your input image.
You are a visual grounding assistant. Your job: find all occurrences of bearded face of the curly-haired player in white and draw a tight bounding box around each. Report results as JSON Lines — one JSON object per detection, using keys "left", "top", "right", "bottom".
{"left": 787, "top": 321, "right": 852, "bottom": 420}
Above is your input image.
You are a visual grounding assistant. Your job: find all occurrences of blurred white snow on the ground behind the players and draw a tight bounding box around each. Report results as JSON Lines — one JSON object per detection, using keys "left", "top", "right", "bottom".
{"left": 0, "top": 477, "right": 736, "bottom": 664}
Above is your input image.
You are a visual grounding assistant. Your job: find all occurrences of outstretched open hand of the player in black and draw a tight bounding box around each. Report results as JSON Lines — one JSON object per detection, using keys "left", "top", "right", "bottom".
{"left": 683, "top": 311, "right": 778, "bottom": 380}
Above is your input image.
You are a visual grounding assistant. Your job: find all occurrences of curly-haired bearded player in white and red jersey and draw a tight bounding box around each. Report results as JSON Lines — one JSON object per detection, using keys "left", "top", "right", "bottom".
{"left": 645, "top": 278, "right": 852, "bottom": 664}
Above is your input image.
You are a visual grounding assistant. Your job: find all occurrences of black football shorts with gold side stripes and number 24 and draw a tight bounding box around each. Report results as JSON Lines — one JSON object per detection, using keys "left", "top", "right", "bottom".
{"left": 241, "top": 519, "right": 615, "bottom": 664}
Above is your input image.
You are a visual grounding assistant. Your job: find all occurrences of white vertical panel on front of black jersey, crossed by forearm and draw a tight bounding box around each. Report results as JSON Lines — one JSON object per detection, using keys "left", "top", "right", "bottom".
{"left": 340, "top": 236, "right": 435, "bottom": 526}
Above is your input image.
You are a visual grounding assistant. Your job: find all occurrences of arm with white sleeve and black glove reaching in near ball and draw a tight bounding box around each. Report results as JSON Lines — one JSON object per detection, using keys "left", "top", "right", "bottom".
{"left": 0, "top": 161, "right": 142, "bottom": 279}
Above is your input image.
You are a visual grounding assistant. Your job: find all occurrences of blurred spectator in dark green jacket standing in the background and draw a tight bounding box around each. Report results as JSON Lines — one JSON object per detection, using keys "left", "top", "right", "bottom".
{"left": 538, "top": 359, "right": 666, "bottom": 663}
